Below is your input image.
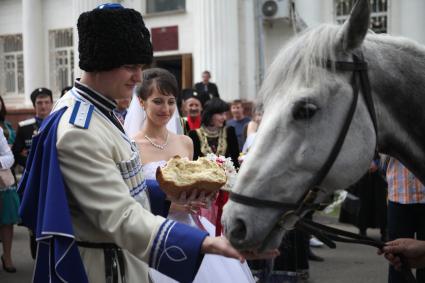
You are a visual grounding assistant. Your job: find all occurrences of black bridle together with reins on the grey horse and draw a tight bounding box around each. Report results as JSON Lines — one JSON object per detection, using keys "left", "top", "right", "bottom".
{"left": 229, "top": 52, "right": 416, "bottom": 283}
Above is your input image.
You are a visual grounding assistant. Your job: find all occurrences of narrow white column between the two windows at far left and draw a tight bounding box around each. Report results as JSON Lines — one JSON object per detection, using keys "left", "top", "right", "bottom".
{"left": 22, "top": 0, "right": 47, "bottom": 106}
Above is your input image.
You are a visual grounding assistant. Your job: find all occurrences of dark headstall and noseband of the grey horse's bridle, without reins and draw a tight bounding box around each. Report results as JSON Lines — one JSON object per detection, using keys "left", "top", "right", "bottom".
{"left": 230, "top": 52, "right": 378, "bottom": 221}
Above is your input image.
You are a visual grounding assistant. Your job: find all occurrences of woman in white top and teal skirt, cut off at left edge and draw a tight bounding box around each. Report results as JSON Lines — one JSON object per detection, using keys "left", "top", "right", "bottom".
{"left": 0, "top": 128, "right": 19, "bottom": 273}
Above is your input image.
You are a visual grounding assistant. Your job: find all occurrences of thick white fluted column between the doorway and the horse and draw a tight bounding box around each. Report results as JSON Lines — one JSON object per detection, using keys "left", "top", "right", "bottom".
{"left": 194, "top": 0, "right": 240, "bottom": 101}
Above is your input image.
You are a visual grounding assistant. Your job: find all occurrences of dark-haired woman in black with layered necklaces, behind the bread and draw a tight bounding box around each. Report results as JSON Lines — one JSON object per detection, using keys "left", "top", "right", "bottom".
{"left": 189, "top": 98, "right": 239, "bottom": 236}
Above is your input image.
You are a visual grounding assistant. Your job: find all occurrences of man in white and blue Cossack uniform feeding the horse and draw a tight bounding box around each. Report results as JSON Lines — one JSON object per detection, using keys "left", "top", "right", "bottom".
{"left": 19, "top": 3, "right": 272, "bottom": 283}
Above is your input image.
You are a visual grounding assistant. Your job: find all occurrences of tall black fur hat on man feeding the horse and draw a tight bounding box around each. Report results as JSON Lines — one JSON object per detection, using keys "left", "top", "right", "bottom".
{"left": 77, "top": 3, "right": 153, "bottom": 72}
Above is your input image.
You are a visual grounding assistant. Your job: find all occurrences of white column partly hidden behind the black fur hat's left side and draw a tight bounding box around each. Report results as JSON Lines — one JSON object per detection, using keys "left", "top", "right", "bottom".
{"left": 71, "top": 0, "right": 119, "bottom": 78}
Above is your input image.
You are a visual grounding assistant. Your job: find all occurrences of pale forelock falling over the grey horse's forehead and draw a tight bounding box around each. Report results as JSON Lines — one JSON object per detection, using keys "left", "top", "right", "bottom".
{"left": 260, "top": 24, "right": 340, "bottom": 108}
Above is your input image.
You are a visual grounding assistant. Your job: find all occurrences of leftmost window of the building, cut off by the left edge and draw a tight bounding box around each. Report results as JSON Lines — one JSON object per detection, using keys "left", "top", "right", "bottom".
{"left": 0, "top": 34, "right": 24, "bottom": 95}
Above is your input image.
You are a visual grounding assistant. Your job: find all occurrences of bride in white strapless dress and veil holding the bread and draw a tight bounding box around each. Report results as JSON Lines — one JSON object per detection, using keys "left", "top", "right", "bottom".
{"left": 124, "top": 68, "right": 254, "bottom": 283}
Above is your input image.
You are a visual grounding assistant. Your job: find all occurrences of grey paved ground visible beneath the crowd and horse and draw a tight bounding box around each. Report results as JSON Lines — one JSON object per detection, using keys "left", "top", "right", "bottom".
{"left": 0, "top": 217, "right": 387, "bottom": 283}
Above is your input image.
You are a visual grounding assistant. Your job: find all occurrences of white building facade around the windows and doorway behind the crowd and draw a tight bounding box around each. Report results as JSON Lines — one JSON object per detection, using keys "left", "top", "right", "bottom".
{"left": 0, "top": 0, "right": 425, "bottom": 111}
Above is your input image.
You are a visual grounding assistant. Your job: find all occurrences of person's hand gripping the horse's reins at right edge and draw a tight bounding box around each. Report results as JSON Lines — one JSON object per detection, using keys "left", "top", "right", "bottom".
{"left": 378, "top": 238, "right": 425, "bottom": 270}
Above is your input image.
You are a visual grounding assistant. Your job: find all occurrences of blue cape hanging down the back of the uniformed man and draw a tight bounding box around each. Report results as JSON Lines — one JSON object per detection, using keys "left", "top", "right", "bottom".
{"left": 19, "top": 107, "right": 88, "bottom": 283}
